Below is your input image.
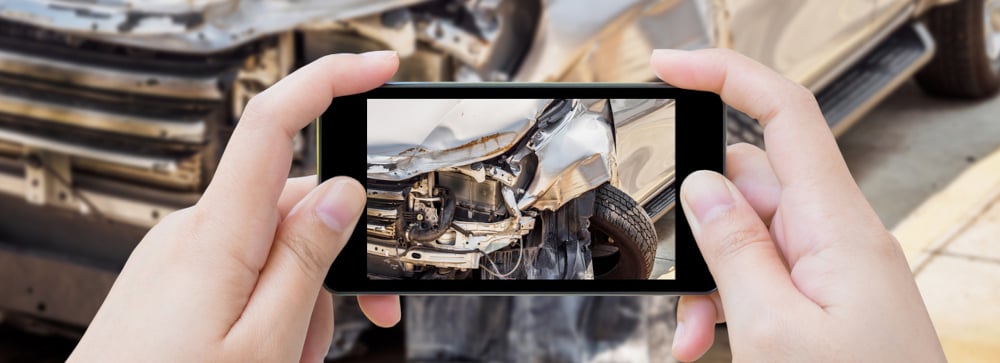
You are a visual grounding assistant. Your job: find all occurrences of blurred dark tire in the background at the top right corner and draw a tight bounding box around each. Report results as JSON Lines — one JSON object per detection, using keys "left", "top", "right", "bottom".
{"left": 916, "top": 0, "right": 1000, "bottom": 99}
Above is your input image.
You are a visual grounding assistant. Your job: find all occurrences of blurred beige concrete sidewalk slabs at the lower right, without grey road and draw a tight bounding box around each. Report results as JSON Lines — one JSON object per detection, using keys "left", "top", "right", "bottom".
{"left": 893, "top": 144, "right": 1000, "bottom": 362}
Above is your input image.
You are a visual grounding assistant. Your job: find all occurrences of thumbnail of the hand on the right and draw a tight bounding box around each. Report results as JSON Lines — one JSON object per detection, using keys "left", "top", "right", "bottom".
{"left": 681, "top": 171, "right": 733, "bottom": 224}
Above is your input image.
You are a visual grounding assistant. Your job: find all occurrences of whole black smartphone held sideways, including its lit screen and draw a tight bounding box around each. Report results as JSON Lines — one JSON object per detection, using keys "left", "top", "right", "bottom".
{"left": 317, "top": 83, "right": 726, "bottom": 295}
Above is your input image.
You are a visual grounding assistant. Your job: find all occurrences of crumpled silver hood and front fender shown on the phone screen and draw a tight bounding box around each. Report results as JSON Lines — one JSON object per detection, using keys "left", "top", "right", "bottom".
{"left": 367, "top": 99, "right": 615, "bottom": 210}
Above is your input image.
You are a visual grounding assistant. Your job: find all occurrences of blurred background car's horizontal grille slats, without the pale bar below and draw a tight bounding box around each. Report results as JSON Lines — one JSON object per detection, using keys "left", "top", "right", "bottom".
{"left": 0, "top": 21, "right": 270, "bottom": 191}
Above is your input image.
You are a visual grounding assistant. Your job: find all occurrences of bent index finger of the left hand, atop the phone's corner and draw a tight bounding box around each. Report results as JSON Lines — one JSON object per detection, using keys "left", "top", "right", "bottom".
{"left": 198, "top": 51, "right": 399, "bottom": 263}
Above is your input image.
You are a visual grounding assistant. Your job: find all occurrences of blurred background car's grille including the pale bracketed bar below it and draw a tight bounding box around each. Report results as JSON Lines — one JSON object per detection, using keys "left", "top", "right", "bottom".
{"left": 0, "top": 20, "right": 290, "bottom": 226}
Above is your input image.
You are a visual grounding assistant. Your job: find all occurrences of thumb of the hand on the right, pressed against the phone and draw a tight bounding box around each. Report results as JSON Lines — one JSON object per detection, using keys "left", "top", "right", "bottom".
{"left": 681, "top": 170, "right": 801, "bottom": 323}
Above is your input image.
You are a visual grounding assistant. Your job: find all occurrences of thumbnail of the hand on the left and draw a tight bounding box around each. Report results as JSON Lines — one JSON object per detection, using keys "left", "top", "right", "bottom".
{"left": 316, "top": 177, "right": 365, "bottom": 231}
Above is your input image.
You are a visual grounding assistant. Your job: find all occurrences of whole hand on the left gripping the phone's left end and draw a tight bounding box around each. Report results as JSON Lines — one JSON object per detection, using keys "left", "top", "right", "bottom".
{"left": 69, "top": 52, "right": 400, "bottom": 362}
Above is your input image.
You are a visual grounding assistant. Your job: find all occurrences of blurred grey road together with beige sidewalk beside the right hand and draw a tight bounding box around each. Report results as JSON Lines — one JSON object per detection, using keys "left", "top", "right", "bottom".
{"left": 839, "top": 83, "right": 1000, "bottom": 362}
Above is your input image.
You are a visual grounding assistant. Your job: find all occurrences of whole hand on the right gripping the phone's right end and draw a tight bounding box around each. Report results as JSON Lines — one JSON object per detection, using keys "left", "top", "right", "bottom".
{"left": 652, "top": 49, "right": 944, "bottom": 362}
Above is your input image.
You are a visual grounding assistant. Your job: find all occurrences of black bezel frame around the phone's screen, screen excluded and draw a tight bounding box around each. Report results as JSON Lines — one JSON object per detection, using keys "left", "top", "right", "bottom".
{"left": 316, "top": 82, "right": 726, "bottom": 295}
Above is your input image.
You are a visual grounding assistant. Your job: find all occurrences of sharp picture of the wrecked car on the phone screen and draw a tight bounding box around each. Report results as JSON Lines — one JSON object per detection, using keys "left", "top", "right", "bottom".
{"left": 363, "top": 98, "right": 677, "bottom": 280}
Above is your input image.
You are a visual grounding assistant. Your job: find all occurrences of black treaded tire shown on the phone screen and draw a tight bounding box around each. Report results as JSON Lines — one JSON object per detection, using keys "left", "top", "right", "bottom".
{"left": 590, "top": 184, "right": 657, "bottom": 280}
